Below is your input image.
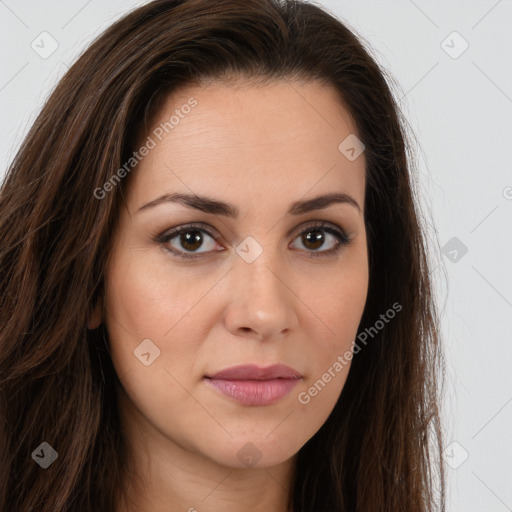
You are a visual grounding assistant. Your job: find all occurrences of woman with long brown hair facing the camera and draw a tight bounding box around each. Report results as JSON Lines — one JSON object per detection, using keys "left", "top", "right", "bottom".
{"left": 0, "top": 0, "right": 444, "bottom": 512}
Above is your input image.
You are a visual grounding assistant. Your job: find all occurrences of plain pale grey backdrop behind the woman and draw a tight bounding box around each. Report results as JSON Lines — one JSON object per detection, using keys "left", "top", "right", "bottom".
{"left": 0, "top": 0, "right": 512, "bottom": 512}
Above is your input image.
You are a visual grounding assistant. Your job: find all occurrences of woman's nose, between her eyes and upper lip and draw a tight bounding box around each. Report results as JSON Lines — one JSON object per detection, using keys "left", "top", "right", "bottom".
{"left": 225, "top": 250, "right": 298, "bottom": 341}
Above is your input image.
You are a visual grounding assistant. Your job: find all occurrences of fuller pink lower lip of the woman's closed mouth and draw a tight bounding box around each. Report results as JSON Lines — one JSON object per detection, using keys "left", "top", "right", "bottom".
{"left": 206, "top": 379, "right": 300, "bottom": 405}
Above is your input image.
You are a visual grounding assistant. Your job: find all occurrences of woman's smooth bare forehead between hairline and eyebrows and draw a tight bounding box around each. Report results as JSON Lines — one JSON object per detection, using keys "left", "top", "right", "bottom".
{"left": 125, "top": 77, "right": 365, "bottom": 208}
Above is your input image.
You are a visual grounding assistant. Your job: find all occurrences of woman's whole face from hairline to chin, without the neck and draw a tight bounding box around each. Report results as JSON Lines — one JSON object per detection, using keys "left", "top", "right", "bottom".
{"left": 96, "top": 81, "right": 368, "bottom": 468}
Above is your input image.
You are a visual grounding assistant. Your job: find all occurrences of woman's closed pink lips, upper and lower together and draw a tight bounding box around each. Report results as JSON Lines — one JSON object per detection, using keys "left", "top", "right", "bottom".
{"left": 205, "top": 364, "right": 302, "bottom": 406}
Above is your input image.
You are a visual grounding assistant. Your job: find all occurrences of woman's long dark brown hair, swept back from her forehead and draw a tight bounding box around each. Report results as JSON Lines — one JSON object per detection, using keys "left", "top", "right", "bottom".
{"left": 0, "top": 0, "right": 445, "bottom": 512}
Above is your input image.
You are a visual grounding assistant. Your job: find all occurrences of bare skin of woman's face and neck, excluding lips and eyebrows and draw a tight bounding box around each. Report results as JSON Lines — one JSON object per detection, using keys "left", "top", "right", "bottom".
{"left": 90, "top": 77, "right": 368, "bottom": 512}
